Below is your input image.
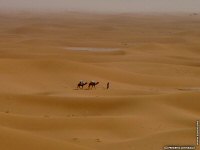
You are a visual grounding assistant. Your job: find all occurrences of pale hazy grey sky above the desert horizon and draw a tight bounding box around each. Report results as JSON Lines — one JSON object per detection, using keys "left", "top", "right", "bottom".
{"left": 0, "top": 0, "right": 200, "bottom": 12}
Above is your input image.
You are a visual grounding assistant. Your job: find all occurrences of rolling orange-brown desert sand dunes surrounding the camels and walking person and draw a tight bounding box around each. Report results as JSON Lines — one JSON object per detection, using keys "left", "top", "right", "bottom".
{"left": 0, "top": 12, "right": 200, "bottom": 150}
